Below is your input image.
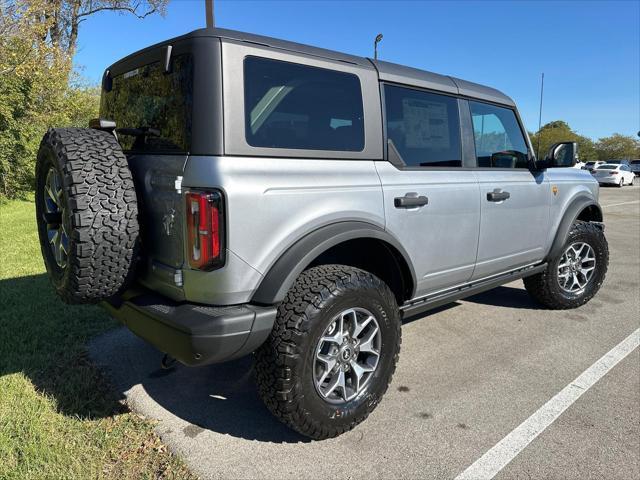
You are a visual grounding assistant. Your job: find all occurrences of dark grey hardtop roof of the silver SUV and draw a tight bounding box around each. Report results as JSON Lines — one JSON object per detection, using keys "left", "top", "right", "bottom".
{"left": 109, "top": 28, "right": 515, "bottom": 106}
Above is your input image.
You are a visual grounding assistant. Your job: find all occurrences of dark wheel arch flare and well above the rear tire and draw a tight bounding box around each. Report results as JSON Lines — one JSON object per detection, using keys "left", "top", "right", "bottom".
{"left": 251, "top": 221, "right": 417, "bottom": 304}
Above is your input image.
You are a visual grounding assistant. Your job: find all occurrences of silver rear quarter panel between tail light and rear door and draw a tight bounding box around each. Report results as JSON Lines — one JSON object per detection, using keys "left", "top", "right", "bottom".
{"left": 183, "top": 157, "right": 385, "bottom": 303}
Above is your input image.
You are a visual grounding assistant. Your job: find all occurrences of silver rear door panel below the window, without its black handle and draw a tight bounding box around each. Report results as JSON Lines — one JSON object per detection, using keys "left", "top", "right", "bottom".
{"left": 376, "top": 162, "right": 480, "bottom": 296}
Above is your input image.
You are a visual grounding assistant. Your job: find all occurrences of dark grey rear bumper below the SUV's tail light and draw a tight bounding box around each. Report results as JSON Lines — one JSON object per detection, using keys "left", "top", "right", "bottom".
{"left": 101, "top": 292, "right": 276, "bottom": 366}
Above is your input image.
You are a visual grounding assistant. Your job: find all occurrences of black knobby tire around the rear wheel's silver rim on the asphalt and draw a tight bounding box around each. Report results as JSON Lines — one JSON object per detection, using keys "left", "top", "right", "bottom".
{"left": 256, "top": 265, "right": 401, "bottom": 440}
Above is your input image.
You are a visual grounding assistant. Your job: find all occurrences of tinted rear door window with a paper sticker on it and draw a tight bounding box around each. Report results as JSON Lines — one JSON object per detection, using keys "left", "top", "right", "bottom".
{"left": 384, "top": 85, "right": 462, "bottom": 167}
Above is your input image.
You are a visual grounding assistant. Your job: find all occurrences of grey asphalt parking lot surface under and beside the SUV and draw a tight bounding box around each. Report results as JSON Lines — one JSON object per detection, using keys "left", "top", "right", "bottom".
{"left": 91, "top": 186, "right": 640, "bottom": 479}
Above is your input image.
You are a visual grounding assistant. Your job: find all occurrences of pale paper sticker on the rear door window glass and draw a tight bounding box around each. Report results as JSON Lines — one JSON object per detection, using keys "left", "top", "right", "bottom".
{"left": 402, "top": 98, "right": 449, "bottom": 148}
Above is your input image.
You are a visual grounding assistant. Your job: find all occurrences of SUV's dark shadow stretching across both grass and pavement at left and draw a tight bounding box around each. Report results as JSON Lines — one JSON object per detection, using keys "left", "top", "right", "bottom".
{"left": 0, "top": 274, "right": 308, "bottom": 443}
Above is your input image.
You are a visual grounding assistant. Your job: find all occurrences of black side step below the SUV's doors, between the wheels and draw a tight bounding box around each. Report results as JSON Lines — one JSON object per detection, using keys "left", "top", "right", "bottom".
{"left": 400, "top": 263, "right": 547, "bottom": 317}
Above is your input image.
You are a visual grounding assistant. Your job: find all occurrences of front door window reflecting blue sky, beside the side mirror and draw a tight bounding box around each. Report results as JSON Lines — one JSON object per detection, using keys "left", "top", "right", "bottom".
{"left": 469, "top": 101, "right": 529, "bottom": 168}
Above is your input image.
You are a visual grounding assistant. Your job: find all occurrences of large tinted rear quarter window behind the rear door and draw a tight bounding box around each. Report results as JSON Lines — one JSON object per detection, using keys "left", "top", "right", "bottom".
{"left": 244, "top": 57, "right": 364, "bottom": 151}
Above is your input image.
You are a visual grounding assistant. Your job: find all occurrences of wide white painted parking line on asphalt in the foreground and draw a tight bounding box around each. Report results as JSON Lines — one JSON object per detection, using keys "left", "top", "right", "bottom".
{"left": 455, "top": 328, "right": 640, "bottom": 480}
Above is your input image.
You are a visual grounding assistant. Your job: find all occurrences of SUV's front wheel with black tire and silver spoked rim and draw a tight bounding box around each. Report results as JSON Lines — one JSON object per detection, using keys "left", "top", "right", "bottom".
{"left": 524, "top": 221, "right": 609, "bottom": 310}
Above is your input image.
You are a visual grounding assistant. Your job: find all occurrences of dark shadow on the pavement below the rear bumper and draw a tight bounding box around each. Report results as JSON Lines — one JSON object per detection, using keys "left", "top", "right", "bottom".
{"left": 89, "top": 328, "right": 309, "bottom": 443}
